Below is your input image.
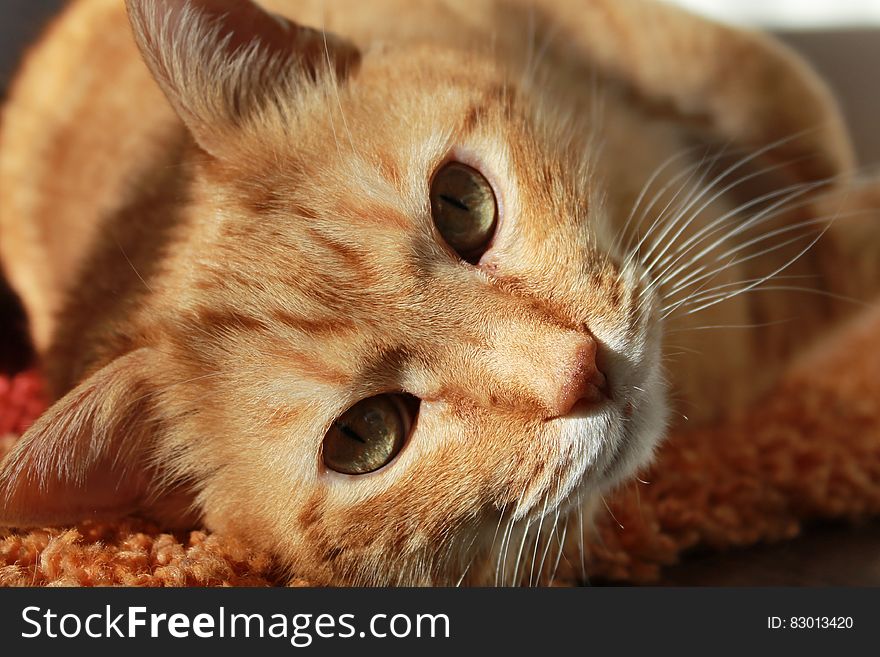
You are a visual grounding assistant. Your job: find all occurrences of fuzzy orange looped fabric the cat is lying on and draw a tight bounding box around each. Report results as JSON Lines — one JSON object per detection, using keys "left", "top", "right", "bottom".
{"left": 0, "top": 308, "right": 880, "bottom": 586}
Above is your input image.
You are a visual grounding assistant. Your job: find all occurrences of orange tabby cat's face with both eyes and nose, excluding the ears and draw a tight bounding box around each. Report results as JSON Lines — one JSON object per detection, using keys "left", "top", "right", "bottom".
{"left": 131, "top": 14, "right": 666, "bottom": 583}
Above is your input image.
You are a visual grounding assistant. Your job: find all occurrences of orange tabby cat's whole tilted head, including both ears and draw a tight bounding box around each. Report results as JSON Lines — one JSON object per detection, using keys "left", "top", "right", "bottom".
{"left": 3, "top": 0, "right": 848, "bottom": 583}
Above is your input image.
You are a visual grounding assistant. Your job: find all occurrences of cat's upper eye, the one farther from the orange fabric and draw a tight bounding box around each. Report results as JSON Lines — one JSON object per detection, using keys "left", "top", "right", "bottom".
{"left": 431, "top": 162, "right": 498, "bottom": 264}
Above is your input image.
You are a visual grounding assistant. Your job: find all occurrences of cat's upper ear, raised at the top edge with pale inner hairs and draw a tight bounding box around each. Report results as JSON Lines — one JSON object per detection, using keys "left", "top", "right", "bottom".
{"left": 125, "top": 0, "right": 360, "bottom": 157}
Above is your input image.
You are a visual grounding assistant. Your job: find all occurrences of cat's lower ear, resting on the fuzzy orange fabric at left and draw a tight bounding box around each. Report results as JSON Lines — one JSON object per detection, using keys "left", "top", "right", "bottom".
{"left": 0, "top": 348, "right": 188, "bottom": 527}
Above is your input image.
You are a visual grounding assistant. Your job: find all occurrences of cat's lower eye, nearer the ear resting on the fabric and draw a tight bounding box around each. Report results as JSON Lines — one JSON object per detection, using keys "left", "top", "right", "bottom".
{"left": 322, "top": 394, "right": 417, "bottom": 475}
